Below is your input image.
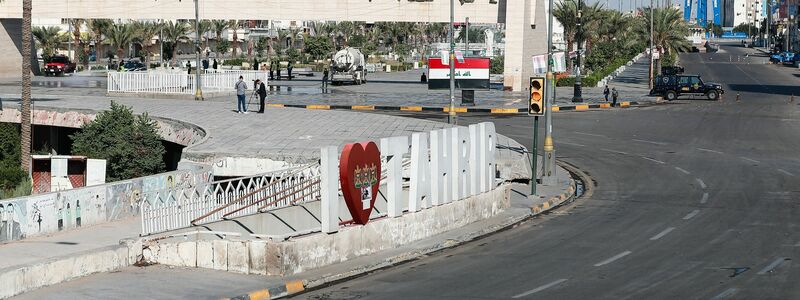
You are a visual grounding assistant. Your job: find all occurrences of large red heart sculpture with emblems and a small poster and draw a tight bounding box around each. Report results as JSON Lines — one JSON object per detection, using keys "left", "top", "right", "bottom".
{"left": 339, "top": 142, "right": 381, "bottom": 225}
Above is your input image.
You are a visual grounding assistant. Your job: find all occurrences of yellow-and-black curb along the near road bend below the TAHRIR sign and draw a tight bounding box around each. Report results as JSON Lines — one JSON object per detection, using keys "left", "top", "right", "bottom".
{"left": 222, "top": 178, "right": 576, "bottom": 300}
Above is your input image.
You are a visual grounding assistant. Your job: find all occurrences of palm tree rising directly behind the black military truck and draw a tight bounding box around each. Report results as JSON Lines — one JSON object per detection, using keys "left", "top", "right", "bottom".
{"left": 634, "top": 8, "right": 691, "bottom": 74}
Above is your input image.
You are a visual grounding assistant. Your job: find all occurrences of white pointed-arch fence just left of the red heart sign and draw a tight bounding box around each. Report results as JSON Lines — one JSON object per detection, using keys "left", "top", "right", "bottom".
{"left": 140, "top": 165, "right": 320, "bottom": 235}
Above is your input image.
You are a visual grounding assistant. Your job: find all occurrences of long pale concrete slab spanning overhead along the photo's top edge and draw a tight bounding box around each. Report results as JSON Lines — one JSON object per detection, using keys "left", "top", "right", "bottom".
{"left": 0, "top": 0, "right": 499, "bottom": 23}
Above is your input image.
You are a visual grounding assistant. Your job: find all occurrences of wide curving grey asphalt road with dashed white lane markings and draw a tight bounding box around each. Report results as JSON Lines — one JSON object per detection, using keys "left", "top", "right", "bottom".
{"left": 294, "top": 45, "right": 800, "bottom": 299}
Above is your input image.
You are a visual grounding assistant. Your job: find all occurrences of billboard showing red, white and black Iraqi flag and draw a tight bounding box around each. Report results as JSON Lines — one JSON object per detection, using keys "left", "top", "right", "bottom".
{"left": 428, "top": 57, "right": 489, "bottom": 90}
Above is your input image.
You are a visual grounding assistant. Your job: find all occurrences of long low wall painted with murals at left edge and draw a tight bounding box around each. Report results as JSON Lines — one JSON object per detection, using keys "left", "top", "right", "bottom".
{"left": 0, "top": 167, "right": 213, "bottom": 242}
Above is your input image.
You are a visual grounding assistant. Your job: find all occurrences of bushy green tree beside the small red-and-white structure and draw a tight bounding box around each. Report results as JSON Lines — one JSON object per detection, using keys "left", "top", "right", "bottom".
{"left": 70, "top": 101, "right": 165, "bottom": 182}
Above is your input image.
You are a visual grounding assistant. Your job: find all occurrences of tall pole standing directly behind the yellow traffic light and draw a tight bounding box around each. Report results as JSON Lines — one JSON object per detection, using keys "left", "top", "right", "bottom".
{"left": 544, "top": 0, "right": 556, "bottom": 185}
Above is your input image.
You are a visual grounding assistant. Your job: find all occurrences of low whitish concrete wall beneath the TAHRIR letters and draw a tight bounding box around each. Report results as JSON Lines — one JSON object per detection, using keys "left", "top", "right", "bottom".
{"left": 142, "top": 185, "right": 510, "bottom": 275}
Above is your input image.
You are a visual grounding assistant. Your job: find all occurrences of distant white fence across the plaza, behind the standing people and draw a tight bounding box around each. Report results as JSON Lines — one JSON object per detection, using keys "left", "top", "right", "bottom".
{"left": 108, "top": 70, "right": 268, "bottom": 95}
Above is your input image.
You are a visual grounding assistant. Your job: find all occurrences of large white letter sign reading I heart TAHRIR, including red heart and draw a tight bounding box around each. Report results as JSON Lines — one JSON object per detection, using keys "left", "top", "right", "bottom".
{"left": 320, "top": 122, "right": 497, "bottom": 233}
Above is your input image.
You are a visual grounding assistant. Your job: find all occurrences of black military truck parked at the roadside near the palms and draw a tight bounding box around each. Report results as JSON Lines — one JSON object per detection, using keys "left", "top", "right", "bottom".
{"left": 650, "top": 74, "right": 725, "bottom": 101}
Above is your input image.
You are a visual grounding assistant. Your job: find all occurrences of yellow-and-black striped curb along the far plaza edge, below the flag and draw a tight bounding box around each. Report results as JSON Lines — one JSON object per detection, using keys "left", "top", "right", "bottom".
{"left": 266, "top": 101, "right": 642, "bottom": 114}
